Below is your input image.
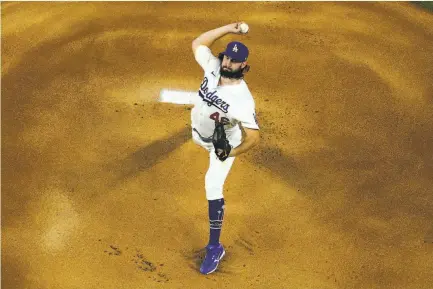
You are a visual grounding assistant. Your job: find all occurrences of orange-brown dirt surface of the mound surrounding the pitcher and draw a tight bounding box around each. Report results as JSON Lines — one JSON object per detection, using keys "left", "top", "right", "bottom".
{"left": 1, "top": 2, "right": 433, "bottom": 289}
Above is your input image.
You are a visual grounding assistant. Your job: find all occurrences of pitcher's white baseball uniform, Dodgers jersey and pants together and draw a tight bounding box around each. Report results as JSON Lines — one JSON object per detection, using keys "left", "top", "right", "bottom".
{"left": 191, "top": 45, "right": 259, "bottom": 200}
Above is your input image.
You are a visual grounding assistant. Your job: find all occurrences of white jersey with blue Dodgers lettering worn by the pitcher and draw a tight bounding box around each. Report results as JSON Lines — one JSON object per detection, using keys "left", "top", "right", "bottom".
{"left": 191, "top": 45, "right": 259, "bottom": 137}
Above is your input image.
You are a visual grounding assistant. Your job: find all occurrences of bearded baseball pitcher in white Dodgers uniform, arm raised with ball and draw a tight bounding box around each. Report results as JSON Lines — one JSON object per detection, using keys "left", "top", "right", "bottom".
{"left": 191, "top": 22, "right": 259, "bottom": 274}
